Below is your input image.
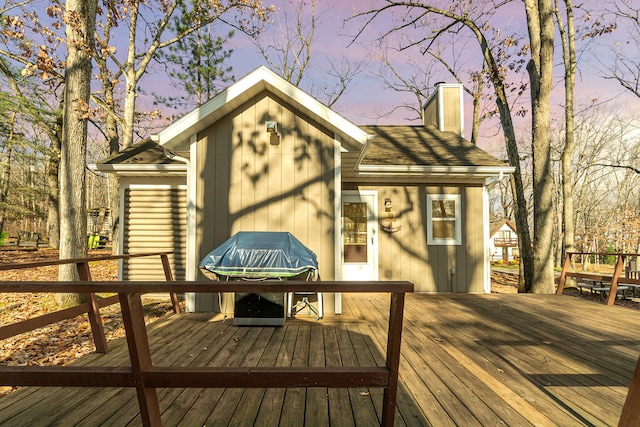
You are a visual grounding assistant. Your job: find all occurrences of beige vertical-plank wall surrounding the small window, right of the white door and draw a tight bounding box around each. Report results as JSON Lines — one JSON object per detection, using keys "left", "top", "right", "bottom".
{"left": 343, "top": 183, "right": 485, "bottom": 293}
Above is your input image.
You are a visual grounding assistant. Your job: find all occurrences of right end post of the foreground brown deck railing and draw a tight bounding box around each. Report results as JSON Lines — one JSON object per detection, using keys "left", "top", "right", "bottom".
{"left": 380, "top": 293, "right": 405, "bottom": 426}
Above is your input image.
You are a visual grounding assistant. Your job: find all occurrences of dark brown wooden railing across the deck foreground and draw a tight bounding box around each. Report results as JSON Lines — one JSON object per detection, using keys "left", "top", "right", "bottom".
{"left": 0, "top": 281, "right": 413, "bottom": 426}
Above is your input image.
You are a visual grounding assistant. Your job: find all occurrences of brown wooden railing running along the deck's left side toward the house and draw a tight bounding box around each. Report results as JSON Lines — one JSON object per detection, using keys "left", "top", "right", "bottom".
{"left": 0, "top": 252, "right": 180, "bottom": 353}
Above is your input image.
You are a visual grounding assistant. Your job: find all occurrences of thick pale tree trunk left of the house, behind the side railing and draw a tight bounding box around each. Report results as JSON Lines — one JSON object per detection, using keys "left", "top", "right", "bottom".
{"left": 56, "top": 0, "right": 98, "bottom": 305}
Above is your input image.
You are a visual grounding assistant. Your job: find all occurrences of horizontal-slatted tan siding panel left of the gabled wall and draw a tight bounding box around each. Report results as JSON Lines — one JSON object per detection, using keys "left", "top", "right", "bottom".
{"left": 122, "top": 186, "right": 187, "bottom": 280}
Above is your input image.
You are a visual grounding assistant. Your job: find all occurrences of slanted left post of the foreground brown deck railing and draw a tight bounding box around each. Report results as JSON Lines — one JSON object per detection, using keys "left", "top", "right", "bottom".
{"left": 118, "top": 294, "right": 162, "bottom": 427}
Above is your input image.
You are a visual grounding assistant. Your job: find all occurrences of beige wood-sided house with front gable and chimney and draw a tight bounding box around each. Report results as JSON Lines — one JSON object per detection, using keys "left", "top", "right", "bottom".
{"left": 90, "top": 67, "right": 513, "bottom": 313}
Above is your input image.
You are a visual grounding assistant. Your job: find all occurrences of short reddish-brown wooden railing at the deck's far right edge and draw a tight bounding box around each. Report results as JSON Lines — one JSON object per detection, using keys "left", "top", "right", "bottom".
{"left": 556, "top": 252, "right": 640, "bottom": 305}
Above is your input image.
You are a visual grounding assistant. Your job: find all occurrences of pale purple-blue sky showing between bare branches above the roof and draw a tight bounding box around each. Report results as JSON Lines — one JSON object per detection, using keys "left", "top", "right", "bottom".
{"left": 140, "top": 0, "right": 640, "bottom": 154}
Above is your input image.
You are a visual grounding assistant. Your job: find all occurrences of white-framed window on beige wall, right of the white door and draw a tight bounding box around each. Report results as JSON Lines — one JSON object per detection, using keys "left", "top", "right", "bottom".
{"left": 427, "top": 194, "right": 461, "bottom": 245}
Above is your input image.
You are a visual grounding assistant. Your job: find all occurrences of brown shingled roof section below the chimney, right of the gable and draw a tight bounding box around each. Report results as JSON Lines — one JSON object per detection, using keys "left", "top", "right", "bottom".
{"left": 357, "top": 125, "right": 514, "bottom": 177}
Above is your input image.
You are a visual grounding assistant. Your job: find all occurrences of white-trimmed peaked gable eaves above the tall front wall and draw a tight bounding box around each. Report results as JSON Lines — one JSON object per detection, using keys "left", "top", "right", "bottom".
{"left": 153, "top": 62, "right": 367, "bottom": 150}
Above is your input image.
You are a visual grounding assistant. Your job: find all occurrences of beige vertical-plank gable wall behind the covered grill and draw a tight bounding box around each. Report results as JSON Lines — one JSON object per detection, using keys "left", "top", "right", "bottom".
{"left": 196, "top": 91, "right": 335, "bottom": 280}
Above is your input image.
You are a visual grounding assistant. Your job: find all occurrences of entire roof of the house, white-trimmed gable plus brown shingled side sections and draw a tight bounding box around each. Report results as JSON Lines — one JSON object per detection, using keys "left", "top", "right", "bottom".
{"left": 89, "top": 67, "right": 515, "bottom": 180}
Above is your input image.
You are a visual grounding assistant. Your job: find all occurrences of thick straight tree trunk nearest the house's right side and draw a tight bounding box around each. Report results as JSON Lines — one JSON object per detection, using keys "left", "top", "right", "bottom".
{"left": 525, "top": 0, "right": 555, "bottom": 293}
